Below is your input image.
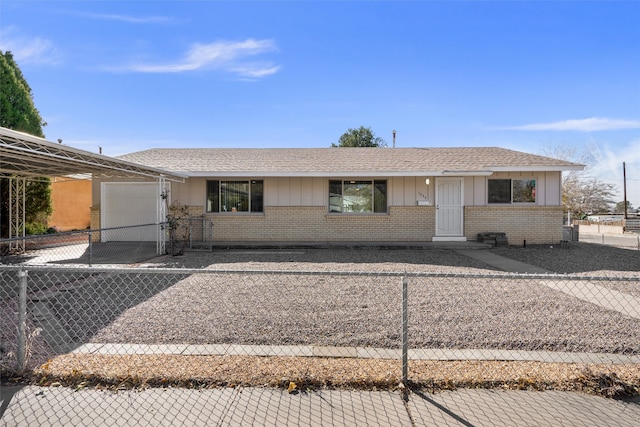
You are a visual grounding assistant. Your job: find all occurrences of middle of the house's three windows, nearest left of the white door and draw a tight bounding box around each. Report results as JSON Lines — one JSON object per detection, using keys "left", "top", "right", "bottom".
{"left": 329, "top": 180, "right": 387, "bottom": 213}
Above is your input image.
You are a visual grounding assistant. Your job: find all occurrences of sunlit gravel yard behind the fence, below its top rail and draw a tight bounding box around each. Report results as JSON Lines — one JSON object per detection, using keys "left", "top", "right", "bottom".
{"left": 84, "top": 273, "right": 640, "bottom": 354}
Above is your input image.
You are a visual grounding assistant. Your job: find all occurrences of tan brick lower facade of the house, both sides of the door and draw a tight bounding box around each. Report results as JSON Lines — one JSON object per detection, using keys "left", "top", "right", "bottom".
{"left": 202, "top": 206, "right": 562, "bottom": 245}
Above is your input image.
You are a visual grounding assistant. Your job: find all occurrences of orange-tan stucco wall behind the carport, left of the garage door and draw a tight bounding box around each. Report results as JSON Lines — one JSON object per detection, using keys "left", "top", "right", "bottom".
{"left": 47, "top": 180, "right": 91, "bottom": 231}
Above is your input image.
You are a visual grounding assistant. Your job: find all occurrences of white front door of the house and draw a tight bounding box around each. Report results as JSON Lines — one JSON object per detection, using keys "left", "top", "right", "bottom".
{"left": 433, "top": 178, "right": 465, "bottom": 240}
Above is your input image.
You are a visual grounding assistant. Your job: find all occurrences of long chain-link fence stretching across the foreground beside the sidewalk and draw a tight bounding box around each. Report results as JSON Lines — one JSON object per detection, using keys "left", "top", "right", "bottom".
{"left": 0, "top": 266, "right": 640, "bottom": 424}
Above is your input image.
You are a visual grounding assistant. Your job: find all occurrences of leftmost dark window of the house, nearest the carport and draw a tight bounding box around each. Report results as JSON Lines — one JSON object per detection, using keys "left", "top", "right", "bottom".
{"left": 207, "top": 180, "right": 264, "bottom": 212}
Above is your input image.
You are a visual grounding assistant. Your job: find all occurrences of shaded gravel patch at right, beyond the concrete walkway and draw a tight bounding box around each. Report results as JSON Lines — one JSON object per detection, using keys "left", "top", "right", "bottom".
{"left": 491, "top": 242, "right": 640, "bottom": 274}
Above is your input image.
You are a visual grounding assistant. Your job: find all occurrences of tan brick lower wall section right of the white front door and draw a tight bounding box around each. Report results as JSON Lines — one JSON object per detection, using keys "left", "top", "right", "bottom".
{"left": 464, "top": 206, "right": 563, "bottom": 245}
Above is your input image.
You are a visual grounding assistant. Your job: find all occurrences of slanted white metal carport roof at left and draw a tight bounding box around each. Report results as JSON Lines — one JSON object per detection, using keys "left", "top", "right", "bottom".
{"left": 0, "top": 127, "right": 186, "bottom": 181}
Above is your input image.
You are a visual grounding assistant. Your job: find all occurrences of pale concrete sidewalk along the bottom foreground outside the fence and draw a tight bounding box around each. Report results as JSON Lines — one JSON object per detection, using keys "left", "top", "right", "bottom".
{"left": 0, "top": 386, "right": 640, "bottom": 427}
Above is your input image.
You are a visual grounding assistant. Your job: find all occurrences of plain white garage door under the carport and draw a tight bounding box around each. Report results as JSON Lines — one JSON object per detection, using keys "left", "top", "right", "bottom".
{"left": 100, "top": 182, "right": 158, "bottom": 242}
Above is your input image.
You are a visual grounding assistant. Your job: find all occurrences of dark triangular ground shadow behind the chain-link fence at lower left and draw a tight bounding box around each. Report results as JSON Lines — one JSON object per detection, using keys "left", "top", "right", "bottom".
{"left": 0, "top": 268, "right": 189, "bottom": 368}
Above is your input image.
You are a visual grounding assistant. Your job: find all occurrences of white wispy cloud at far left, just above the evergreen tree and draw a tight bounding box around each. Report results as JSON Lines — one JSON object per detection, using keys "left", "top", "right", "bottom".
{"left": 0, "top": 27, "right": 61, "bottom": 64}
